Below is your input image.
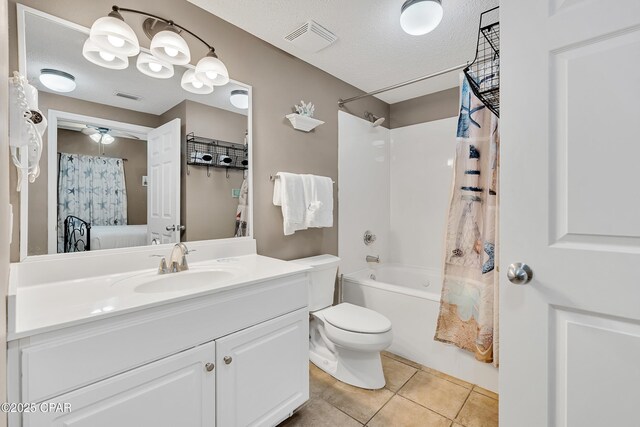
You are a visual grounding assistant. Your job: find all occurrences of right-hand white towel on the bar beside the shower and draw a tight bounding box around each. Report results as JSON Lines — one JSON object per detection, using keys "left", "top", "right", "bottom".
{"left": 302, "top": 175, "right": 333, "bottom": 228}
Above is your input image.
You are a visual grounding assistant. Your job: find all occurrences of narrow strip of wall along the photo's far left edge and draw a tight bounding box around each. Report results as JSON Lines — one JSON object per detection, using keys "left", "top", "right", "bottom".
{"left": 0, "top": 2, "right": 9, "bottom": 427}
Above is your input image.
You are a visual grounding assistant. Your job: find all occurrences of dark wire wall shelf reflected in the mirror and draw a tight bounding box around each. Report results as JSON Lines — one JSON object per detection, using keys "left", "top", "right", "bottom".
{"left": 186, "top": 132, "right": 249, "bottom": 170}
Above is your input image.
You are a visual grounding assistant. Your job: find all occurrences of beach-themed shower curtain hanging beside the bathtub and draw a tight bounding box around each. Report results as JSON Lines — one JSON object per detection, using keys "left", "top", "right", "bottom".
{"left": 435, "top": 77, "right": 500, "bottom": 366}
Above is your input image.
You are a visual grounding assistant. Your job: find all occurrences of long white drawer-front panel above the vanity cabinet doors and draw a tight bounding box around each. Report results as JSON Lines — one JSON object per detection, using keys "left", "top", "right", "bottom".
{"left": 20, "top": 274, "right": 308, "bottom": 402}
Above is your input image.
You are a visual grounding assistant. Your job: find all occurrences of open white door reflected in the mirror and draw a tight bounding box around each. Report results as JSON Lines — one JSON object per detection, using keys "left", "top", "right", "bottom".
{"left": 147, "top": 119, "right": 181, "bottom": 243}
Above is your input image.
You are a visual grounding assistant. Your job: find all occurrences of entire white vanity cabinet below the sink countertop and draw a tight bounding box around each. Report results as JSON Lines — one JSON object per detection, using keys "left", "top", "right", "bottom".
{"left": 8, "top": 272, "right": 309, "bottom": 427}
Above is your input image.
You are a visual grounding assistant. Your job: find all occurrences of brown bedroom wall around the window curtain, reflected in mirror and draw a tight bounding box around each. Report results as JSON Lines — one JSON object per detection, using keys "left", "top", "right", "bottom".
{"left": 57, "top": 129, "right": 147, "bottom": 226}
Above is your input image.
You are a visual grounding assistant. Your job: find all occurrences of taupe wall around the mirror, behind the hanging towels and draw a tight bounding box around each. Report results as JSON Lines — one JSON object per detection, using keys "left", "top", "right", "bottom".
{"left": 9, "top": 0, "right": 389, "bottom": 259}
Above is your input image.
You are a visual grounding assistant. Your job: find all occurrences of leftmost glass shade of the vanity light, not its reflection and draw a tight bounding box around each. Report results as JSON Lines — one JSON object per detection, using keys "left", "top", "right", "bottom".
{"left": 89, "top": 6, "right": 140, "bottom": 56}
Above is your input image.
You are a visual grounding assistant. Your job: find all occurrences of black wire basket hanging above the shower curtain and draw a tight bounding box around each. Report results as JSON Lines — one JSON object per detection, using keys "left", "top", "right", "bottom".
{"left": 463, "top": 7, "right": 500, "bottom": 117}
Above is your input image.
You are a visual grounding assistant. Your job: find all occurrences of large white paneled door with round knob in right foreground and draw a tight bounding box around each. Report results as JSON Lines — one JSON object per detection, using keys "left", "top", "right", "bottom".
{"left": 500, "top": 0, "right": 640, "bottom": 427}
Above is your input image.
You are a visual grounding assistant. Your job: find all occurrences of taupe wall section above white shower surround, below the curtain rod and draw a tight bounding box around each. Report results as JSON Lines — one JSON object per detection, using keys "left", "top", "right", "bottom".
{"left": 389, "top": 87, "right": 460, "bottom": 129}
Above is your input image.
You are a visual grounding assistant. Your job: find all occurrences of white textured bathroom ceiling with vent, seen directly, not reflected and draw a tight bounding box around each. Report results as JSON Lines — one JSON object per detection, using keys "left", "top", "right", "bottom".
{"left": 188, "top": 0, "right": 498, "bottom": 104}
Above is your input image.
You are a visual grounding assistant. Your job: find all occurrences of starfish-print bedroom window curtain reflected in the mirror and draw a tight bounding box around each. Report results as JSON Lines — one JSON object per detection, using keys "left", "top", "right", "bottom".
{"left": 58, "top": 153, "right": 127, "bottom": 252}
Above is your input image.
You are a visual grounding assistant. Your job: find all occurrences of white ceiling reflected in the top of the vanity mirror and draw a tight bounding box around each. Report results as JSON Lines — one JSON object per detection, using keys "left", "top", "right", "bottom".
{"left": 25, "top": 13, "right": 247, "bottom": 115}
